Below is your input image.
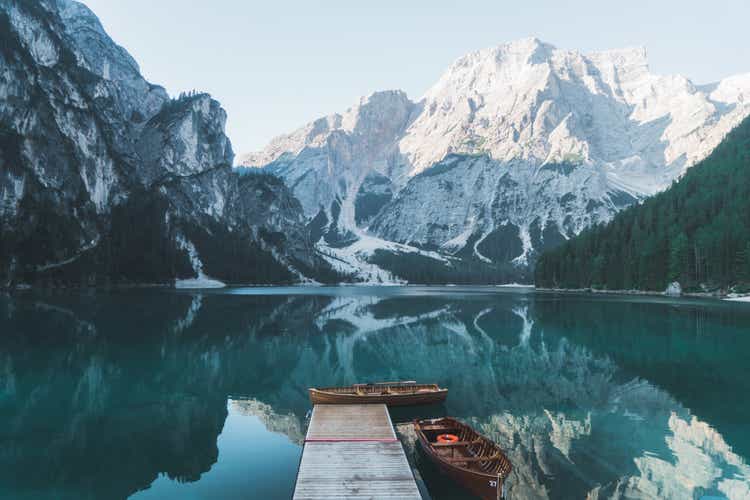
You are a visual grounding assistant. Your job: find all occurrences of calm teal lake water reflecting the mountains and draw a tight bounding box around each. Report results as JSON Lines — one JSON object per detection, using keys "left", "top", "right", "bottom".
{"left": 0, "top": 287, "right": 750, "bottom": 500}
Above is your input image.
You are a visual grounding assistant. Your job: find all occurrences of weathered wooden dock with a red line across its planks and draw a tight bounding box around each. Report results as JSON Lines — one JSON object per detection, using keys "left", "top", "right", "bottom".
{"left": 294, "top": 404, "right": 422, "bottom": 500}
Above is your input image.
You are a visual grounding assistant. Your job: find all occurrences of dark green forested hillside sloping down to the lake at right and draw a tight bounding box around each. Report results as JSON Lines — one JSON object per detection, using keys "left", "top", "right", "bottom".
{"left": 536, "top": 119, "right": 750, "bottom": 291}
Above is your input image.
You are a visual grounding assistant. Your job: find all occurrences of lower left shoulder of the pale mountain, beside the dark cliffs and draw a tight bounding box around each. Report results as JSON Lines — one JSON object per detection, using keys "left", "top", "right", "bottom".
{"left": 248, "top": 91, "right": 415, "bottom": 229}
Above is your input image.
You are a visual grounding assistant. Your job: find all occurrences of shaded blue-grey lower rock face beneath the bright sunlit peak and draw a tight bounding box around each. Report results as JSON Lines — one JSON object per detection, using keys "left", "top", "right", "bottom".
{"left": 370, "top": 154, "right": 624, "bottom": 265}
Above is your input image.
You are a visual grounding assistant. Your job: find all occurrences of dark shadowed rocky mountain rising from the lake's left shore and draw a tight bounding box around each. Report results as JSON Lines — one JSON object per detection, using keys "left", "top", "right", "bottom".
{"left": 0, "top": 0, "right": 328, "bottom": 286}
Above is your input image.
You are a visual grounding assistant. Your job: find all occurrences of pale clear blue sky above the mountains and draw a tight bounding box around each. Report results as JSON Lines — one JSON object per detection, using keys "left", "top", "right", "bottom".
{"left": 83, "top": 0, "right": 750, "bottom": 155}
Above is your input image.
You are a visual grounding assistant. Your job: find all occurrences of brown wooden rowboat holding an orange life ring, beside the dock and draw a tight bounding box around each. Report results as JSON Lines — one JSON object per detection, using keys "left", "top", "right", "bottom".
{"left": 414, "top": 418, "right": 512, "bottom": 500}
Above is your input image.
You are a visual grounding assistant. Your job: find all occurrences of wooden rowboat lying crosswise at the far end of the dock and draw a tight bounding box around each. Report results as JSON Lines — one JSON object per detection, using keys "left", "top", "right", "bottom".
{"left": 309, "top": 381, "right": 448, "bottom": 406}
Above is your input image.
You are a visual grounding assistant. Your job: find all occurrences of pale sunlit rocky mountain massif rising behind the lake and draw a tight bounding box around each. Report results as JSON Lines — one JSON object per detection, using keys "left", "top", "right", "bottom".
{"left": 241, "top": 38, "right": 750, "bottom": 278}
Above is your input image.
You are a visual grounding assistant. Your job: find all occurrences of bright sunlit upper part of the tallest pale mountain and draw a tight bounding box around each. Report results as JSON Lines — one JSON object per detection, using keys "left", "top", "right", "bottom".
{"left": 400, "top": 38, "right": 750, "bottom": 175}
